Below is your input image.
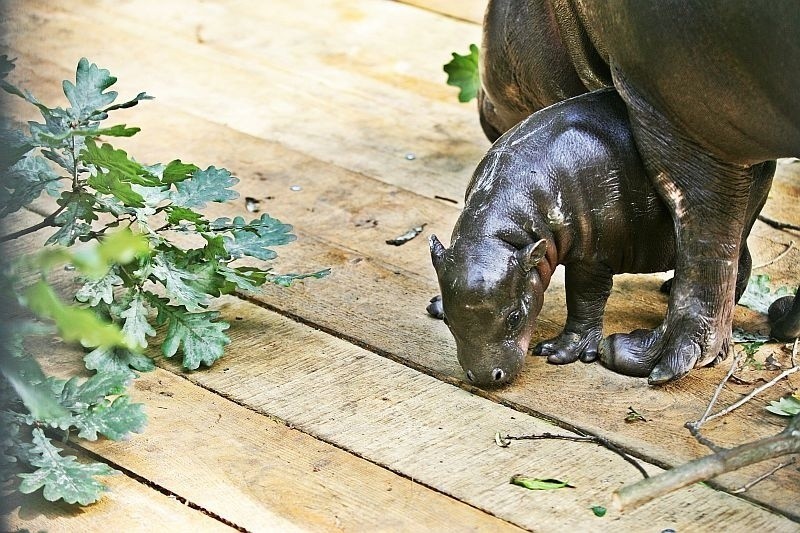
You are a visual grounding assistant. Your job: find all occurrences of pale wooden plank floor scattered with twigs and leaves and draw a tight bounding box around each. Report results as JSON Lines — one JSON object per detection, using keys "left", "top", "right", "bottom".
{"left": 5, "top": 0, "right": 800, "bottom": 531}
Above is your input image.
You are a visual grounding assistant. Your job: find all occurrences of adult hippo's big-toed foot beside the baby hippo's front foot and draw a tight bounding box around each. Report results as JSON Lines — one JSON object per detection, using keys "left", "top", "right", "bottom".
{"left": 598, "top": 329, "right": 729, "bottom": 385}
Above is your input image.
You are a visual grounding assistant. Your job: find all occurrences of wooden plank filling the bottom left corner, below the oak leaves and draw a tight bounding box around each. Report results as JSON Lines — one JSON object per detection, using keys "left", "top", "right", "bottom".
{"left": 0, "top": 451, "right": 235, "bottom": 533}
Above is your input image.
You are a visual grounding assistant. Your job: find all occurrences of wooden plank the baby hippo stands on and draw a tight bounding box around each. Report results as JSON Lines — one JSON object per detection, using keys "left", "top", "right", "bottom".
{"left": 7, "top": 31, "right": 797, "bottom": 512}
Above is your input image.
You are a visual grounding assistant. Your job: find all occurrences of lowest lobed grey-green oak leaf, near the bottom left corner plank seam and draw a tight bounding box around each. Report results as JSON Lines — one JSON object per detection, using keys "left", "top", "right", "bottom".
{"left": 18, "top": 428, "right": 117, "bottom": 505}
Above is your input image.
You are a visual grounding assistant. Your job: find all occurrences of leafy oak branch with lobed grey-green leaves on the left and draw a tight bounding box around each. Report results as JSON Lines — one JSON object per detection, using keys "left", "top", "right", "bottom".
{"left": 0, "top": 56, "right": 328, "bottom": 504}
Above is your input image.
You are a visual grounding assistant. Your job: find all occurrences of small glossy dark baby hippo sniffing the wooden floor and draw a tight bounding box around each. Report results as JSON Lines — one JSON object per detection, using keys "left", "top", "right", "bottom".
{"left": 431, "top": 89, "right": 774, "bottom": 386}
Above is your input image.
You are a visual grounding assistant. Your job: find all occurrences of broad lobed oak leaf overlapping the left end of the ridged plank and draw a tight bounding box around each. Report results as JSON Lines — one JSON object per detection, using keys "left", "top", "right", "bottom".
{"left": 151, "top": 298, "right": 230, "bottom": 370}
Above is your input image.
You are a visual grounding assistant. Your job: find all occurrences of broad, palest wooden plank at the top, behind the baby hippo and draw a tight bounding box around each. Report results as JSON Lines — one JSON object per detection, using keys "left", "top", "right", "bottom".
{"left": 6, "top": 0, "right": 489, "bottom": 202}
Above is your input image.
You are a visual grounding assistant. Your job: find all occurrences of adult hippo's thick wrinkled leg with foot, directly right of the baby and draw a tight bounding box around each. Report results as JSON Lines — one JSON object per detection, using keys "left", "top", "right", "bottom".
{"left": 599, "top": 72, "right": 752, "bottom": 384}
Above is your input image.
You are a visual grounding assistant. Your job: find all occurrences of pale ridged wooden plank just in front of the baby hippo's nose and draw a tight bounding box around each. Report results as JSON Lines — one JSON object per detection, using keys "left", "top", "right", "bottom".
{"left": 147, "top": 299, "right": 797, "bottom": 531}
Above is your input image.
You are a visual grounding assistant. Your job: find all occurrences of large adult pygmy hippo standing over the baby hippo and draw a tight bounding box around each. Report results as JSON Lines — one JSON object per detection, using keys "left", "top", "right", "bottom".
{"left": 468, "top": 0, "right": 800, "bottom": 384}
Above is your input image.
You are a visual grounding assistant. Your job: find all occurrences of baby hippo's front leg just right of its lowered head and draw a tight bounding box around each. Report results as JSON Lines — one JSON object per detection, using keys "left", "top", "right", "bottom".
{"left": 533, "top": 263, "right": 613, "bottom": 365}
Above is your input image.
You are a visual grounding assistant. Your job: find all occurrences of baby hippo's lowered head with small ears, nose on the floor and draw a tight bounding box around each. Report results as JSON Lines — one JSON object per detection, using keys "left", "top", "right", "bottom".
{"left": 430, "top": 235, "right": 547, "bottom": 386}
